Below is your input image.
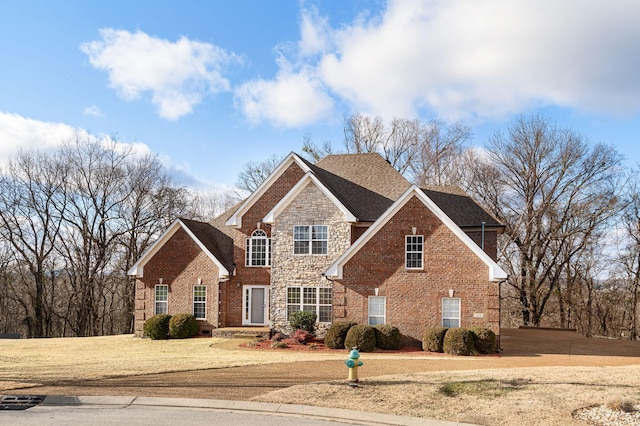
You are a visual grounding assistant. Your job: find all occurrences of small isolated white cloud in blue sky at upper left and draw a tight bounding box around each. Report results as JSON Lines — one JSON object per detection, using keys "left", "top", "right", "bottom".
{"left": 80, "top": 28, "right": 239, "bottom": 120}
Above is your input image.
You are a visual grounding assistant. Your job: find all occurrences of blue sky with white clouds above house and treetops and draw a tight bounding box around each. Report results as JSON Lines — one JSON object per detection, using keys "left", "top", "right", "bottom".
{"left": 0, "top": 0, "right": 640, "bottom": 188}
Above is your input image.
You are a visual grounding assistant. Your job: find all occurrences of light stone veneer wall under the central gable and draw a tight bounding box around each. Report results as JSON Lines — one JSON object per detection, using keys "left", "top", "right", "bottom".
{"left": 270, "top": 183, "right": 351, "bottom": 335}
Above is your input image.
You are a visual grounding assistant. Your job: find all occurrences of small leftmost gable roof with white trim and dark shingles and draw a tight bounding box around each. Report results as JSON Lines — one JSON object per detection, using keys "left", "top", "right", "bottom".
{"left": 128, "top": 218, "right": 233, "bottom": 280}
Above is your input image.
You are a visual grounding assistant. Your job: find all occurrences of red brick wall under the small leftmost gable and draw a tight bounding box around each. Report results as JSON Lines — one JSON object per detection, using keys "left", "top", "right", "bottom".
{"left": 135, "top": 228, "right": 220, "bottom": 336}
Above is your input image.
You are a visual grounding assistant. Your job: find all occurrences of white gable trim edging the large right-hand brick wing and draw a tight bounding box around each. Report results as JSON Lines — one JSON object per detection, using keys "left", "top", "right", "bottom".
{"left": 324, "top": 185, "right": 507, "bottom": 281}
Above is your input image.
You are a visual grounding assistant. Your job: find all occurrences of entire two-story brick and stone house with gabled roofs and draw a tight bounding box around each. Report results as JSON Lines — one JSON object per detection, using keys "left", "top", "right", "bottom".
{"left": 130, "top": 153, "right": 506, "bottom": 342}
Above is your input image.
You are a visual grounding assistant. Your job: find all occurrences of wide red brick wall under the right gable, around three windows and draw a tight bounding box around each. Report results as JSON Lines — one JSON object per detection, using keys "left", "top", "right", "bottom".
{"left": 334, "top": 197, "right": 500, "bottom": 344}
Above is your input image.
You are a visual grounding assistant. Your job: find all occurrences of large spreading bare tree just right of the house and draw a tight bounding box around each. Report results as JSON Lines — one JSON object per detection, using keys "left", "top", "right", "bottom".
{"left": 470, "top": 116, "right": 621, "bottom": 326}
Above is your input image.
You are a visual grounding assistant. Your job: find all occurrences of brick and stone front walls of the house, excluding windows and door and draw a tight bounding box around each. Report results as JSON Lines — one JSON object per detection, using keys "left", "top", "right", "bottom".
{"left": 135, "top": 153, "right": 500, "bottom": 344}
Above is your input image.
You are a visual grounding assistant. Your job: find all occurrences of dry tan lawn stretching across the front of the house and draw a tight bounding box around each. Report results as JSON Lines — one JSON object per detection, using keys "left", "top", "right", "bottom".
{"left": 0, "top": 330, "right": 640, "bottom": 425}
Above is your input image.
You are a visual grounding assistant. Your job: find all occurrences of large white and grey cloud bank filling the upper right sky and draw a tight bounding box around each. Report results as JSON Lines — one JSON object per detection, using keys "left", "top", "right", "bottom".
{"left": 239, "top": 0, "right": 640, "bottom": 125}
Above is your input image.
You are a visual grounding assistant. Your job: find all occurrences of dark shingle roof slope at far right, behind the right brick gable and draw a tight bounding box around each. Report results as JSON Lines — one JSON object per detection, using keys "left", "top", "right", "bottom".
{"left": 422, "top": 186, "right": 503, "bottom": 228}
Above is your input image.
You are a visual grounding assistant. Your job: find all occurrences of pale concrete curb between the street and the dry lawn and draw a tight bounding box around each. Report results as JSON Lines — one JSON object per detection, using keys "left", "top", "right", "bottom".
{"left": 40, "top": 395, "right": 474, "bottom": 426}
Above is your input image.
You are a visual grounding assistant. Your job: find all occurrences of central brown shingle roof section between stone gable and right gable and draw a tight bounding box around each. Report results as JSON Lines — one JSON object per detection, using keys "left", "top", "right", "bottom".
{"left": 310, "top": 153, "right": 411, "bottom": 221}
